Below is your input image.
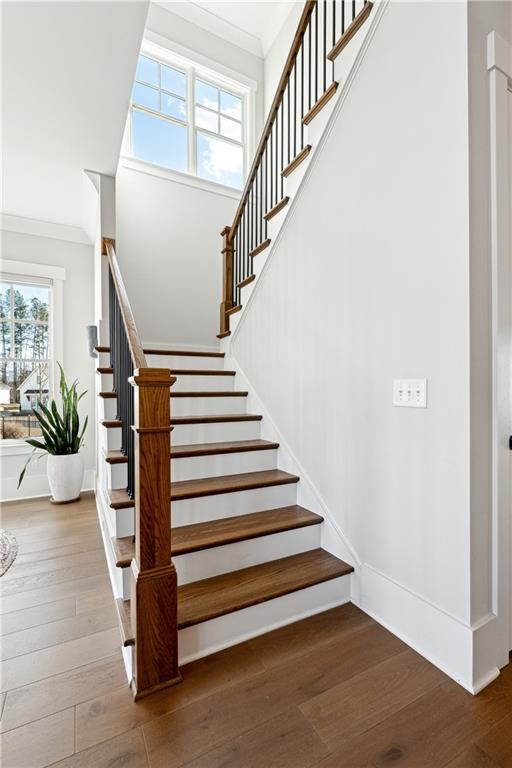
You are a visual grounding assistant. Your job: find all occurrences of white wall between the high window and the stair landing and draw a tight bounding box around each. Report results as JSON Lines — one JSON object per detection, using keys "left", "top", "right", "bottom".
{"left": 116, "top": 164, "right": 237, "bottom": 347}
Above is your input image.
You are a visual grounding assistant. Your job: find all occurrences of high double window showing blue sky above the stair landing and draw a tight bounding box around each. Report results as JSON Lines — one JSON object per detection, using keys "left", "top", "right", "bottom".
{"left": 129, "top": 54, "right": 246, "bottom": 189}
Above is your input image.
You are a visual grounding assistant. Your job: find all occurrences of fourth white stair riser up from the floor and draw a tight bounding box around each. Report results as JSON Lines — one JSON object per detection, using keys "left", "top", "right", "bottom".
{"left": 105, "top": 448, "right": 277, "bottom": 489}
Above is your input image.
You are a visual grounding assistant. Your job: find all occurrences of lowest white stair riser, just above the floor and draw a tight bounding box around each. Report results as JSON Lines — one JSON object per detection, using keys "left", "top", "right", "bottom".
{"left": 178, "top": 576, "right": 350, "bottom": 664}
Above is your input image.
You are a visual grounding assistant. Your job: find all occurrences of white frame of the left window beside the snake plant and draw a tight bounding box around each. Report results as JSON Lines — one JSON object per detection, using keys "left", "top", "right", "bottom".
{"left": 0, "top": 259, "right": 66, "bottom": 456}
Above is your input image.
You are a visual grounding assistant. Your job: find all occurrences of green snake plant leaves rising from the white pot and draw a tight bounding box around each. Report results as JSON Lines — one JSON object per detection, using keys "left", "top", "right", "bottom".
{"left": 18, "top": 363, "right": 88, "bottom": 488}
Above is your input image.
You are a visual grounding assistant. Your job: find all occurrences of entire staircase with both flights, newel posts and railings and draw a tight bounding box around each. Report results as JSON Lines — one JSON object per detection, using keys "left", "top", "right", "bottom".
{"left": 97, "top": 0, "right": 372, "bottom": 698}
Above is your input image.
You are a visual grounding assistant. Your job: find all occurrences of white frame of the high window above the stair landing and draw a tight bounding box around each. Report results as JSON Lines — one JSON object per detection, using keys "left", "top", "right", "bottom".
{"left": 121, "top": 34, "right": 256, "bottom": 198}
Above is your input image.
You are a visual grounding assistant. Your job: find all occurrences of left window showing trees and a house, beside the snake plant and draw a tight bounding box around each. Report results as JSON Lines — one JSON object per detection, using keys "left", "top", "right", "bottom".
{"left": 0, "top": 276, "right": 51, "bottom": 440}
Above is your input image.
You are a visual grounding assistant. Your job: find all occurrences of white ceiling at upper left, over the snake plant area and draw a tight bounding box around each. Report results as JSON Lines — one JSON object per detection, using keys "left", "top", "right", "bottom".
{"left": 2, "top": 0, "right": 148, "bottom": 232}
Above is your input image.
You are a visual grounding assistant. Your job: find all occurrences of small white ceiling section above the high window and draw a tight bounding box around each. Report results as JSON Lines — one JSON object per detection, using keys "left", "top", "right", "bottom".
{"left": 154, "top": 0, "right": 294, "bottom": 57}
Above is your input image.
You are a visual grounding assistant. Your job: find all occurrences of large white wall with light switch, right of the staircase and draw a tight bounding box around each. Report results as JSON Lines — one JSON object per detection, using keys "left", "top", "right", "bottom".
{"left": 231, "top": 3, "right": 482, "bottom": 686}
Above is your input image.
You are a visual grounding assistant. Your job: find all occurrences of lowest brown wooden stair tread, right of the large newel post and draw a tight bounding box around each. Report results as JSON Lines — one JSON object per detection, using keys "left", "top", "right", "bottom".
{"left": 178, "top": 549, "right": 354, "bottom": 629}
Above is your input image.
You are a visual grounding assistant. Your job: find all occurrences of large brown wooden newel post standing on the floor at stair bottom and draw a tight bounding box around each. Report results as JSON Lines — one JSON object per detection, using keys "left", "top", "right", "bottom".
{"left": 130, "top": 368, "right": 181, "bottom": 698}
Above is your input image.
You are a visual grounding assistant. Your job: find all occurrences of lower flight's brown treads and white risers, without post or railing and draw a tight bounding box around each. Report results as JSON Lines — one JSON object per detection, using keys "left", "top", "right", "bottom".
{"left": 97, "top": 347, "right": 353, "bottom": 660}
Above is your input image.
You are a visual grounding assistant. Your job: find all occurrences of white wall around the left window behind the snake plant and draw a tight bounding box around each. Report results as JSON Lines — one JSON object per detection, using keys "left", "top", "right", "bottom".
{"left": 0, "top": 231, "right": 97, "bottom": 499}
